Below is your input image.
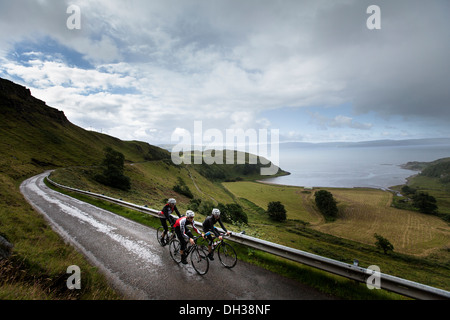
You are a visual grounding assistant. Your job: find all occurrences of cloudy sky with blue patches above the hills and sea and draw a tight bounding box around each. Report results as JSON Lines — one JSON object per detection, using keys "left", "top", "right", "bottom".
{"left": 0, "top": 0, "right": 450, "bottom": 144}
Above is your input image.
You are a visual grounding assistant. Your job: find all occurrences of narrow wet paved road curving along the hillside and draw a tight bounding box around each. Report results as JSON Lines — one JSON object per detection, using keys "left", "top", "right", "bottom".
{"left": 20, "top": 173, "right": 329, "bottom": 300}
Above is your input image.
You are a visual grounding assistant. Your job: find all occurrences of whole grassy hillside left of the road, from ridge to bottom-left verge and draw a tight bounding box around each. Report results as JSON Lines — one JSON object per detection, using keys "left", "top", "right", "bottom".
{"left": 0, "top": 79, "right": 170, "bottom": 299}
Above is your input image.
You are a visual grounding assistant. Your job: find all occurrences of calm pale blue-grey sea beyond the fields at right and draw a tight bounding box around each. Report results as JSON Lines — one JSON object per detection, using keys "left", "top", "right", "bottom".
{"left": 264, "top": 141, "right": 450, "bottom": 190}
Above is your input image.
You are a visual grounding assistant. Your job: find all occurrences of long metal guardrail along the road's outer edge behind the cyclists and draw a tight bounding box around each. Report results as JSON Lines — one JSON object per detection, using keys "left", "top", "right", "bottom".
{"left": 47, "top": 173, "right": 450, "bottom": 300}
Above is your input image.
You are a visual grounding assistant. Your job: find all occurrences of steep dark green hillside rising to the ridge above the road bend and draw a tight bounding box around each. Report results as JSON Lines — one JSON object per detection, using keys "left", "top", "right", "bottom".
{"left": 0, "top": 78, "right": 170, "bottom": 178}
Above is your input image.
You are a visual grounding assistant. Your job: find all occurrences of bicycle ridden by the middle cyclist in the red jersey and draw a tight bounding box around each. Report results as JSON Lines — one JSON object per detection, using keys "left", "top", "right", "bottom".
{"left": 169, "top": 236, "right": 209, "bottom": 275}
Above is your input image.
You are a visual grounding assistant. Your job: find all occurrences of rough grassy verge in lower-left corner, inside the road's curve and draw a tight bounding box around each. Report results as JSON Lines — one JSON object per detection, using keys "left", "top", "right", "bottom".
{"left": 0, "top": 175, "right": 121, "bottom": 300}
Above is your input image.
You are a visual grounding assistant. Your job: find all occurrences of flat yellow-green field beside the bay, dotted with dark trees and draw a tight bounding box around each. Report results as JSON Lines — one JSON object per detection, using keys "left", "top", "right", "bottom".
{"left": 224, "top": 182, "right": 450, "bottom": 256}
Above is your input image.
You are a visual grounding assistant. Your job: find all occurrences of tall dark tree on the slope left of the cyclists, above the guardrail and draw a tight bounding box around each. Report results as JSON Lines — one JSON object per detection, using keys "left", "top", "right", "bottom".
{"left": 94, "top": 147, "right": 131, "bottom": 191}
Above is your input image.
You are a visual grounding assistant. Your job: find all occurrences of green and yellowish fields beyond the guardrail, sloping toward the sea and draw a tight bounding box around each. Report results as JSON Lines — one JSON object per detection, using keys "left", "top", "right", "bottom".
{"left": 47, "top": 162, "right": 450, "bottom": 290}
